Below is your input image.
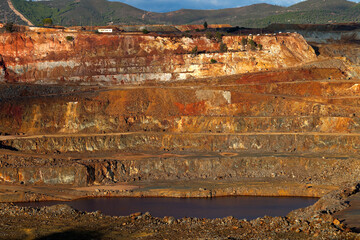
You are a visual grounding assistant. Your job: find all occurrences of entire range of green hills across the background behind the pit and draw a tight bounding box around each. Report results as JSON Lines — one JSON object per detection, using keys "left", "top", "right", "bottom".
{"left": 0, "top": 0, "right": 360, "bottom": 27}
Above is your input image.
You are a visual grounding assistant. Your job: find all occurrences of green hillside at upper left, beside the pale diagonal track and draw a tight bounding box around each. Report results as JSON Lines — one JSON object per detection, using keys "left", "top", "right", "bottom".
{"left": 12, "top": 0, "right": 146, "bottom": 25}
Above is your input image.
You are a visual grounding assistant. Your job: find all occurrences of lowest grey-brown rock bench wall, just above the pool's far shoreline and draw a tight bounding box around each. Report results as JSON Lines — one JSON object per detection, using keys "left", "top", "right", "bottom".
{"left": 0, "top": 153, "right": 360, "bottom": 193}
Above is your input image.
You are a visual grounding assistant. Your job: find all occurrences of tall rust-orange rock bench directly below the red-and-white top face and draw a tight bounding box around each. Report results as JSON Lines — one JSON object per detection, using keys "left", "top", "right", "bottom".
{"left": 0, "top": 69, "right": 352, "bottom": 135}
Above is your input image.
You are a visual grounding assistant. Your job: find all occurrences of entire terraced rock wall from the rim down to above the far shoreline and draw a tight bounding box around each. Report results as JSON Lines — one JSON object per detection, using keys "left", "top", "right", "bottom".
{"left": 0, "top": 29, "right": 360, "bottom": 196}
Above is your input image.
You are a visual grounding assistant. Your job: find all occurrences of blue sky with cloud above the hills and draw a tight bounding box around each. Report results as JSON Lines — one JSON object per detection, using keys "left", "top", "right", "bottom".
{"left": 112, "top": 0, "right": 360, "bottom": 12}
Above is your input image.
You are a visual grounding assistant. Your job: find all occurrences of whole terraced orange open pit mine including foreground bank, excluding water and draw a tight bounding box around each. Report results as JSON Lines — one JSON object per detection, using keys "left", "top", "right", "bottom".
{"left": 0, "top": 25, "right": 360, "bottom": 239}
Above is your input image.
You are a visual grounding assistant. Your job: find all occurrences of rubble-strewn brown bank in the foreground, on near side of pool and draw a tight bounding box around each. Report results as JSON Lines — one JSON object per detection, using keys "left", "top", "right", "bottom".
{"left": 0, "top": 184, "right": 359, "bottom": 239}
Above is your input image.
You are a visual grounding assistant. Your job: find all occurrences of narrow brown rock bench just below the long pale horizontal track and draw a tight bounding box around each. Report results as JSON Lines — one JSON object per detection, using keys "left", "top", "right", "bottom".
{"left": 2, "top": 133, "right": 360, "bottom": 154}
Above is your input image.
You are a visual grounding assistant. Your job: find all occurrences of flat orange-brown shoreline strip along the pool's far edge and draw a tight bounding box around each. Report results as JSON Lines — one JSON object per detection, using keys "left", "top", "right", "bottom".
{"left": 0, "top": 179, "right": 339, "bottom": 203}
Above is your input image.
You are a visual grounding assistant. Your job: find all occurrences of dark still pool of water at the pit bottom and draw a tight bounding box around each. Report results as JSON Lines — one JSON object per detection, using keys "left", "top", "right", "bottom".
{"left": 17, "top": 197, "right": 318, "bottom": 220}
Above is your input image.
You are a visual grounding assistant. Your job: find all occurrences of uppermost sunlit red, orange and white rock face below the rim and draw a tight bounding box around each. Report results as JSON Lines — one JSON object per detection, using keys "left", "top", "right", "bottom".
{"left": 0, "top": 32, "right": 315, "bottom": 85}
